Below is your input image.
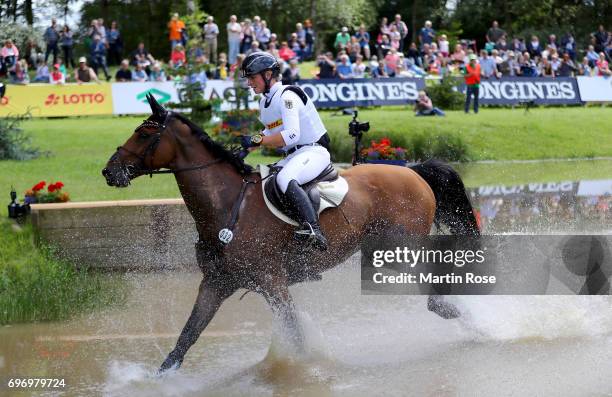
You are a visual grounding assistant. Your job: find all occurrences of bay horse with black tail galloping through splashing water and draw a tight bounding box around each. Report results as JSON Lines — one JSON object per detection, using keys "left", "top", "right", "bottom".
{"left": 102, "top": 95, "right": 480, "bottom": 373}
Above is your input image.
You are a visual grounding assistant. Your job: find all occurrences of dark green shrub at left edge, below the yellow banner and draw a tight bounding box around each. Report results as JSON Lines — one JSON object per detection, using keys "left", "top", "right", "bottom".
{"left": 0, "top": 113, "right": 48, "bottom": 160}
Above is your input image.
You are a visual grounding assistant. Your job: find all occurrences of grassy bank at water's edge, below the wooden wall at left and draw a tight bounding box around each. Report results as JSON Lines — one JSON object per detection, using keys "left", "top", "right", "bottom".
{"left": 0, "top": 217, "right": 127, "bottom": 324}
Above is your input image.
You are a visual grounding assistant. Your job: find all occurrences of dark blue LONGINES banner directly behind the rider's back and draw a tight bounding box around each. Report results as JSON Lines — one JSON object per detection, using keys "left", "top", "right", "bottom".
{"left": 297, "top": 78, "right": 425, "bottom": 108}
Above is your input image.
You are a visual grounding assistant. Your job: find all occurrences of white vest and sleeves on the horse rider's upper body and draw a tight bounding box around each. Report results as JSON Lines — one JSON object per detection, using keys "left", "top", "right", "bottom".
{"left": 259, "top": 82, "right": 326, "bottom": 151}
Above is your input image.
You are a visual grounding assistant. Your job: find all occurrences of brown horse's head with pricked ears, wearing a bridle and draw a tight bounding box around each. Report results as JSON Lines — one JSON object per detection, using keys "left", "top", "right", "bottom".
{"left": 102, "top": 94, "right": 175, "bottom": 187}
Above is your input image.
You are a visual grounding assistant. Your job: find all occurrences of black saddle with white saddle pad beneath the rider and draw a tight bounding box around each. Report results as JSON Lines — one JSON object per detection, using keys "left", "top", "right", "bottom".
{"left": 259, "top": 164, "right": 348, "bottom": 225}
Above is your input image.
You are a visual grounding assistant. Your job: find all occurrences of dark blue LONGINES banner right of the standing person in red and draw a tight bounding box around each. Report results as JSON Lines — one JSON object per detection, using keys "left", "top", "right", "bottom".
{"left": 458, "top": 77, "right": 581, "bottom": 105}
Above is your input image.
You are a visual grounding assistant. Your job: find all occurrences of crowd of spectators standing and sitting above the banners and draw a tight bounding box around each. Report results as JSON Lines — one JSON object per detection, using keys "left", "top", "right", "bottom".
{"left": 0, "top": 14, "right": 612, "bottom": 84}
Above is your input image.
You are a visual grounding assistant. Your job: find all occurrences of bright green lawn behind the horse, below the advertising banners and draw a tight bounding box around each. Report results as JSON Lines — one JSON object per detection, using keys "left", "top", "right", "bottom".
{"left": 0, "top": 107, "right": 612, "bottom": 203}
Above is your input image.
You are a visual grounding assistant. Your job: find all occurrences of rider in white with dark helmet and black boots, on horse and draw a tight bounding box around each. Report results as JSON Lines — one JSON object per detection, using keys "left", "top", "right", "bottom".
{"left": 241, "top": 52, "right": 331, "bottom": 250}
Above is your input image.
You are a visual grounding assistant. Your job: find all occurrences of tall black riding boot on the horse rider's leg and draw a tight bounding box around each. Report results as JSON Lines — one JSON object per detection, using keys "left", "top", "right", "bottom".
{"left": 285, "top": 179, "right": 327, "bottom": 251}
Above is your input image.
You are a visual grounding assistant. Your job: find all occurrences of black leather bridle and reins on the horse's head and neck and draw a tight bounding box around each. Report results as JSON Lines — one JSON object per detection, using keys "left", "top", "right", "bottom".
{"left": 117, "top": 112, "right": 222, "bottom": 178}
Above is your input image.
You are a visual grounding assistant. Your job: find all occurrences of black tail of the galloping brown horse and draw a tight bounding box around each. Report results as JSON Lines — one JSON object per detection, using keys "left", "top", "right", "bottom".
{"left": 410, "top": 159, "right": 480, "bottom": 236}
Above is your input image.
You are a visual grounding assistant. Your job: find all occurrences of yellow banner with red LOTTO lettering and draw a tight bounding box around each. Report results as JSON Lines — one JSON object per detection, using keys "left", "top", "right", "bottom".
{"left": 0, "top": 83, "right": 113, "bottom": 117}
